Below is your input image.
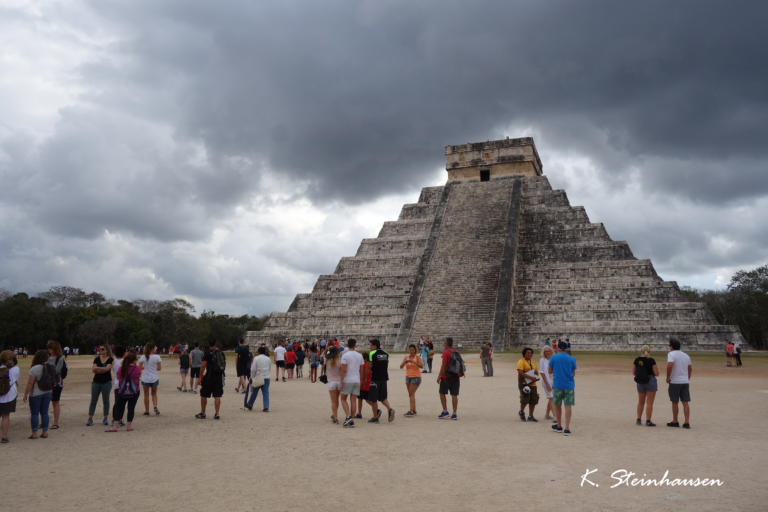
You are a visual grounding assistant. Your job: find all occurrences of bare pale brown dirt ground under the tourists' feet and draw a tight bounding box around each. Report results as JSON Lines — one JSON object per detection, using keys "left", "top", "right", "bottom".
{"left": 0, "top": 353, "right": 768, "bottom": 512}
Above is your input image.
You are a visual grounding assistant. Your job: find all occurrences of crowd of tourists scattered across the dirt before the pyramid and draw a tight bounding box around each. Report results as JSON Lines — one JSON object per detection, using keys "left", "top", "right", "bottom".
{"left": 0, "top": 337, "right": 704, "bottom": 443}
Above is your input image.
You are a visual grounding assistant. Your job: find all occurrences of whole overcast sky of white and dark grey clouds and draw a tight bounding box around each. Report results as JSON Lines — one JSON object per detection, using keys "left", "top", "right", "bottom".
{"left": 0, "top": 0, "right": 768, "bottom": 314}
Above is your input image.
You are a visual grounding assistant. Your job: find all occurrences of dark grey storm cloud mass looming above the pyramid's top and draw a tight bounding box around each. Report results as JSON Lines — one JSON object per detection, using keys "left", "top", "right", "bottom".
{"left": 76, "top": 1, "right": 768, "bottom": 206}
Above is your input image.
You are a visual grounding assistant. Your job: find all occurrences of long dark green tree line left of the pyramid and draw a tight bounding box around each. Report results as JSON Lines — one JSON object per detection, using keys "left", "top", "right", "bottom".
{"left": 0, "top": 286, "right": 268, "bottom": 353}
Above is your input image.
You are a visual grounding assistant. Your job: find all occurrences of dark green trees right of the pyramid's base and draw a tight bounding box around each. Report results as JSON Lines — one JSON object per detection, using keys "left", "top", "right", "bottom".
{"left": 681, "top": 265, "right": 768, "bottom": 349}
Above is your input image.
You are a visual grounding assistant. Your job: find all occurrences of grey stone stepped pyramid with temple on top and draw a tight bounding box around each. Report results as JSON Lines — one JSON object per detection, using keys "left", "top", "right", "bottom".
{"left": 247, "top": 138, "right": 746, "bottom": 350}
